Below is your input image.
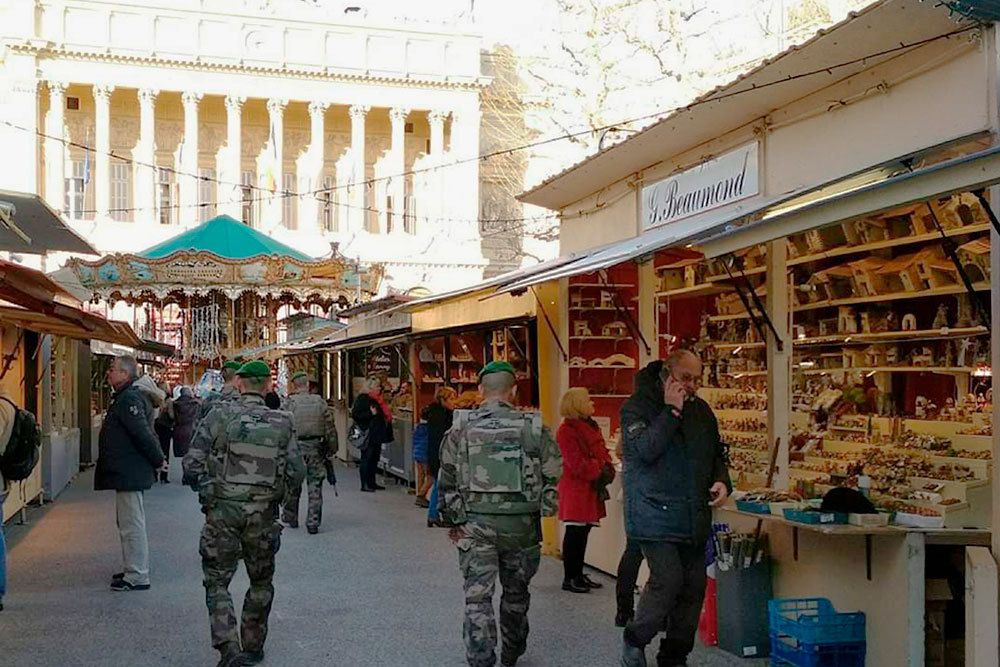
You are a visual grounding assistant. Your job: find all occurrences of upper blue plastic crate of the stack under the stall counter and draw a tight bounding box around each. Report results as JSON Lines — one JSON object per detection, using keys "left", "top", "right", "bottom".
{"left": 767, "top": 598, "right": 865, "bottom": 646}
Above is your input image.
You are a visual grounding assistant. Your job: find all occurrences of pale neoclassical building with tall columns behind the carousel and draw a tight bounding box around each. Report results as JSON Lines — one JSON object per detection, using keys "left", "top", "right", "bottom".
{"left": 0, "top": 0, "right": 488, "bottom": 291}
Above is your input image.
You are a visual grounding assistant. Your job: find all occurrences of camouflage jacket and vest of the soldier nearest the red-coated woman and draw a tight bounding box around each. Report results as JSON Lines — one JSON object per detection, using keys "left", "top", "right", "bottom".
{"left": 438, "top": 401, "right": 562, "bottom": 523}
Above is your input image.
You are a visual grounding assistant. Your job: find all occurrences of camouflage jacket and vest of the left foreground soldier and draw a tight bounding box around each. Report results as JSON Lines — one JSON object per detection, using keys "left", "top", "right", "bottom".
{"left": 184, "top": 394, "right": 305, "bottom": 504}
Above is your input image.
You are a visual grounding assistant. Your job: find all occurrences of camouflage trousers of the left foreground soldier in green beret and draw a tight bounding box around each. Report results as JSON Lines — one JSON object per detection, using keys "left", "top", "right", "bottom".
{"left": 198, "top": 500, "right": 281, "bottom": 652}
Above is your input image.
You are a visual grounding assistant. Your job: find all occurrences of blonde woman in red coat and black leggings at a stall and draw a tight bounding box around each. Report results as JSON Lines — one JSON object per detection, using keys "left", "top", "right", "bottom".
{"left": 556, "top": 387, "right": 614, "bottom": 593}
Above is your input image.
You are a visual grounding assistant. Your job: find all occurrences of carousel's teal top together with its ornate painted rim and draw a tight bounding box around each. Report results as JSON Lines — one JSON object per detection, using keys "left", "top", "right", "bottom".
{"left": 67, "top": 215, "right": 383, "bottom": 303}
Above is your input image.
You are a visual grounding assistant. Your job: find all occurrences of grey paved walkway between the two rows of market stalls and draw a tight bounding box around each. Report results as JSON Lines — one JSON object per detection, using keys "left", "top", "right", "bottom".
{"left": 0, "top": 461, "right": 760, "bottom": 667}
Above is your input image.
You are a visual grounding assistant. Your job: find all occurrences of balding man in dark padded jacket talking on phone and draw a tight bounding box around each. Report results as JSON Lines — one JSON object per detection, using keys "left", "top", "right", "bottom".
{"left": 620, "top": 349, "right": 732, "bottom": 667}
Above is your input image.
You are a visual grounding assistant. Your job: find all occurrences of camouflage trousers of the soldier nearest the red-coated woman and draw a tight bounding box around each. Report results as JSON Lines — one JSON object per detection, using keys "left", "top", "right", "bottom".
{"left": 456, "top": 515, "right": 541, "bottom": 667}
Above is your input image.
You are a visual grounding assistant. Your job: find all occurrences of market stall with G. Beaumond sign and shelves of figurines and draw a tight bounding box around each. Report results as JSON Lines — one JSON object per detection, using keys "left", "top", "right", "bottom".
{"left": 512, "top": 0, "right": 1000, "bottom": 665}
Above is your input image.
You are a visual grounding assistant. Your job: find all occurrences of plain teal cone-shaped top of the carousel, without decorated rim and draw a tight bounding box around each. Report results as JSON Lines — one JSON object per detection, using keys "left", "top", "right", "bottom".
{"left": 139, "top": 215, "right": 315, "bottom": 262}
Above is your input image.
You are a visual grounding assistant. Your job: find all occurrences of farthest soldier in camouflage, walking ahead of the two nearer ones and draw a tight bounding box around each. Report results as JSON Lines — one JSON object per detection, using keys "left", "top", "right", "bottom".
{"left": 281, "top": 372, "right": 337, "bottom": 535}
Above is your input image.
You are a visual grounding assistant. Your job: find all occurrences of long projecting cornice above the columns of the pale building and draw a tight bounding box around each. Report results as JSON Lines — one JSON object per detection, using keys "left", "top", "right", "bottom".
{"left": 7, "top": 42, "right": 492, "bottom": 91}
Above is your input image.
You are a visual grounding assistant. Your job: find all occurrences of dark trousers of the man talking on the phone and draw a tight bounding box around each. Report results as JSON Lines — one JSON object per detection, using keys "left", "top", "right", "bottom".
{"left": 625, "top": 541, "right": 705, "bottom": 667}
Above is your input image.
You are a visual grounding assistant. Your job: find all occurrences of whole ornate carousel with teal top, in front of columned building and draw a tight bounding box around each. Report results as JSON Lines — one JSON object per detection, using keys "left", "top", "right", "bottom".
{"left": 67, "top": 216, "right": 383, "bottom": 379}
